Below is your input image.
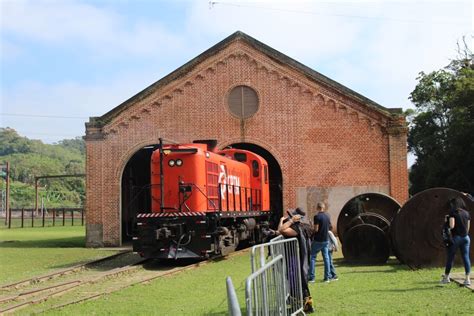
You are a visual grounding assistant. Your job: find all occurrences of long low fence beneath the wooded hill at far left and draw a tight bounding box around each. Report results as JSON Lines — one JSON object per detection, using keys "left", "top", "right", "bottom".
{"left": 0, "top": 208, "right": 85, "bottom": 228}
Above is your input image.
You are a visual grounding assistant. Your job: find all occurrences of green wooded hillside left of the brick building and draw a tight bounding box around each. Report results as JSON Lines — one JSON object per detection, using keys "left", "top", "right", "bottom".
{"left": 0, "top": 128, "right": 85, "bottom": 208}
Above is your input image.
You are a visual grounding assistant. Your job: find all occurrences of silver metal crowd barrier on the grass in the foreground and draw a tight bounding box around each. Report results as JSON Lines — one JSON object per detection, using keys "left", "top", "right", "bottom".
{"left": 227, "top": 236, "right": 305, "bottom": 316}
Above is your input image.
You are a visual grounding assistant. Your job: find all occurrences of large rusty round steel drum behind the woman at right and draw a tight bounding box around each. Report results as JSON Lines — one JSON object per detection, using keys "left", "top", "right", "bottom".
{"left": 390, "top": 188, "right": 474, "bottom": 269}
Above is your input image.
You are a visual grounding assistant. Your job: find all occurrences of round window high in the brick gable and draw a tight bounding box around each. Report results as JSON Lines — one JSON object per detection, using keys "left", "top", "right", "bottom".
{"left": 228, "top": 86, "right": 258, "bottom": 119}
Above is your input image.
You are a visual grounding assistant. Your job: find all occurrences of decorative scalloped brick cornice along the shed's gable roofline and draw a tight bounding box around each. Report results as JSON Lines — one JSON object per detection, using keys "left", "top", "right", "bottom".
{"left": 93, "top": 43, "right": 404, "bottom": 139}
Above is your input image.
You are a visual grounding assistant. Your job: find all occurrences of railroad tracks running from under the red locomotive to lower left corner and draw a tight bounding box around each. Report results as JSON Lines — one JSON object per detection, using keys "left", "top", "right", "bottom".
{"left": 0, "top": 249, "right": 248, "bottom": 314}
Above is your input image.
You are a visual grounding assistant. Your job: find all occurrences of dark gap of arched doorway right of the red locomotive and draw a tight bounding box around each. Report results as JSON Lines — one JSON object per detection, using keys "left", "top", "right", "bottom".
{"left": 225, "top": 143, "right": 283, "bottom": 227}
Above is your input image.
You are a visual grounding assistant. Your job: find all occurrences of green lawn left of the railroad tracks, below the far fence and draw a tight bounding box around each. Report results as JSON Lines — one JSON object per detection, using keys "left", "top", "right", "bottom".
{"left": 0, "top": 226, "right": 114, "bottom": 284}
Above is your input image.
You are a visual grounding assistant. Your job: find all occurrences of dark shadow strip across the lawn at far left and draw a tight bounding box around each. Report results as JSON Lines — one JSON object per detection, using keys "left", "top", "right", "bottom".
{"left": 0, "top": 237, "right": 85, "bottom": 248}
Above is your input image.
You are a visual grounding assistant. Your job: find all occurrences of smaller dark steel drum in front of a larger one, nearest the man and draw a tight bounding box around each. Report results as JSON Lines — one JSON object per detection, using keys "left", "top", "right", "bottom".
{"left": 342, "top": 224, "right": 390, "bottom": 264}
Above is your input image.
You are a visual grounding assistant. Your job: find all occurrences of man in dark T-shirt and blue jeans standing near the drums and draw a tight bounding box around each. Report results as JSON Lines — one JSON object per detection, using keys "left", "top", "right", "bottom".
{"left": 308, "top": 202, "right": 331, "bottom": 282}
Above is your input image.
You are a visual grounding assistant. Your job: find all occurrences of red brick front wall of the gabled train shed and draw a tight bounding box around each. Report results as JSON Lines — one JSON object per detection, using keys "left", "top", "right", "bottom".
{"left": 86, "top": 41, "right": 408, "bottom": 245}
